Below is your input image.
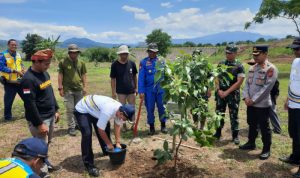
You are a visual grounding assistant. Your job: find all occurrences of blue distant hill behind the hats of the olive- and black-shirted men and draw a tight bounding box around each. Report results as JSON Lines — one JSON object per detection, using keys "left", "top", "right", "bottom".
{"left": 59, "top": 38, "right": 119, "bottom": 48}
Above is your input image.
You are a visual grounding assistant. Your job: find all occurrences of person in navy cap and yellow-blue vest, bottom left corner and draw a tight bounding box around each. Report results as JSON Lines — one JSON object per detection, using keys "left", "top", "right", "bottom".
{"left": 0, "top": 138, "right": 48, "bottom": 178}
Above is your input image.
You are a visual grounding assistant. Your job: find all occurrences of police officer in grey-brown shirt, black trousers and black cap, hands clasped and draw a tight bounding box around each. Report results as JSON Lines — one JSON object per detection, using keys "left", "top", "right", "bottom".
{"left": 239, "top": 45, "right": 278, "bottom": 160}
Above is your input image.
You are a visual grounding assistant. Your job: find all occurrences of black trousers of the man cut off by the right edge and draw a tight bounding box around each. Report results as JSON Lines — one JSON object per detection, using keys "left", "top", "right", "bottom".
{"left": 289, "top": 108, "right": 300, "bottom": 160}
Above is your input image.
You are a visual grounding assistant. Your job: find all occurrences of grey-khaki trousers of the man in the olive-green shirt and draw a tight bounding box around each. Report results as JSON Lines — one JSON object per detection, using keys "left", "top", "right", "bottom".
{"left": 64, "top": 91, "right": 83, "bottom": 129}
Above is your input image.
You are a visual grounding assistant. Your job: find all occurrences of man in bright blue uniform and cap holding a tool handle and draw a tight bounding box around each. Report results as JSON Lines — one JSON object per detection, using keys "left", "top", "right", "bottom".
{"left": 138, "top": 43, "right": 168, "bottom": 135}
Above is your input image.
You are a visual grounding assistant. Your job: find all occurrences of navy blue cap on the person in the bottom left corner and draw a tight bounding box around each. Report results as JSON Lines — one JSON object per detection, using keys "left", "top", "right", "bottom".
{"left": 13, "top": 137, "right": 48, "bottom": 158}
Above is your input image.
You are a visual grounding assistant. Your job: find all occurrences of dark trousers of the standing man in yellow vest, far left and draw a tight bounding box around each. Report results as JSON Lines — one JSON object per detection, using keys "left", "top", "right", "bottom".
{"left": 4, "top": 83, "right": 23, "bottom": 120}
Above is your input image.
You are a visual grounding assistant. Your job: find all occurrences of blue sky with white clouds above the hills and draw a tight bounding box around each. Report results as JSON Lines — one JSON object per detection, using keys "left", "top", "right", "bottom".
{"left": 0, "top": 0, "right": 296, "bottom": 43}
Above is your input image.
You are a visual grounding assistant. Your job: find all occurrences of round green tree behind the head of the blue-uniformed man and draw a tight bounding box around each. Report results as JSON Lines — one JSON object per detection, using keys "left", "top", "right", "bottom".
{"left": 146, "top": 29, "right": 172, "bottom": 57}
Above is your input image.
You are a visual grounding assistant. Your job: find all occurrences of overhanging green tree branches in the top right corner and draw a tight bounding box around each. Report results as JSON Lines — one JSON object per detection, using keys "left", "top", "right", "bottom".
{"left": 245, "top": 0, "right": 300, "bottom": 36}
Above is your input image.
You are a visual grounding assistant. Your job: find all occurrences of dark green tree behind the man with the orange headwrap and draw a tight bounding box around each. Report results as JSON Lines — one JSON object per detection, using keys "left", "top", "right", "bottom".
{"left": 21, "top": 33, "right": 43, "bottom": 60}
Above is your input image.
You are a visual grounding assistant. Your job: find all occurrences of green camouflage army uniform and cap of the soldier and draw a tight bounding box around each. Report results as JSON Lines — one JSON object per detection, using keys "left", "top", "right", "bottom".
{"left": 215, "top": 45, "right": 245, "bottom": 144}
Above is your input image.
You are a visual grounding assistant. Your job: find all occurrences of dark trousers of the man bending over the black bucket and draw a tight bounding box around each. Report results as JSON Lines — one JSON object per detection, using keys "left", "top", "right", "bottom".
{"left": 74, "top": 111, "right": 110, "bottom": 167}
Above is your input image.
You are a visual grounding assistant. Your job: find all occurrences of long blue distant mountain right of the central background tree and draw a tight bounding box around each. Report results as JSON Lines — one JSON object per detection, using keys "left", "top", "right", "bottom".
{"left": 172, "top": 31, "right": 274, "bottom": 44}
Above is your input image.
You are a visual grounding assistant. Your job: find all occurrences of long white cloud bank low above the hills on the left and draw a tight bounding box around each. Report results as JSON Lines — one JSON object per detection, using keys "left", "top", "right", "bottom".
{"left": 0, "top": 17, "right": 144, "bottom": 43}
